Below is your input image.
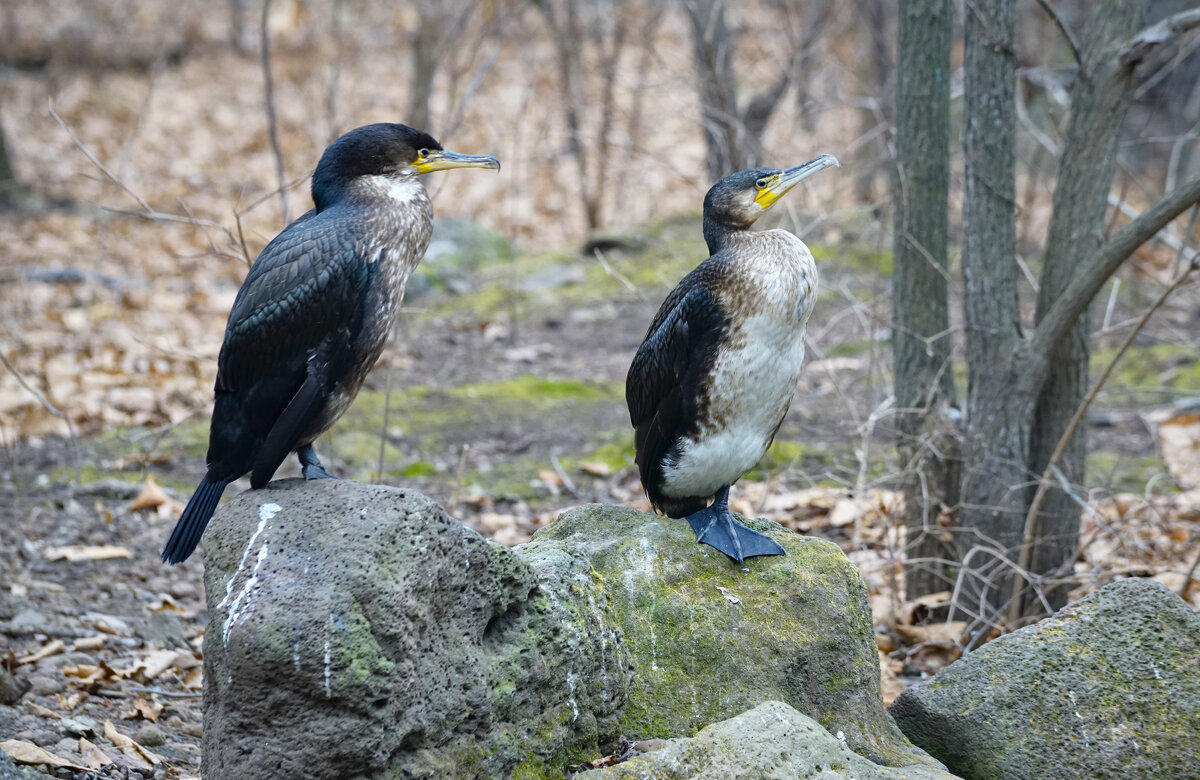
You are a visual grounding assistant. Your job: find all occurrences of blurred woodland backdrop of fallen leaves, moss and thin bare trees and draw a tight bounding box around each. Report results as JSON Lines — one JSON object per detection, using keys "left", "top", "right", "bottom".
{"left": 0, "top": 0, "right": 1200, "bottom": 758}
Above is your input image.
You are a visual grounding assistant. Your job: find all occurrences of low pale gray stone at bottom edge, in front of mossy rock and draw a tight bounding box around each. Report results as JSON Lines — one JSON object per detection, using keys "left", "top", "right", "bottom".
{"left": 592, "top": 702, "right": 954, "bottom": 780}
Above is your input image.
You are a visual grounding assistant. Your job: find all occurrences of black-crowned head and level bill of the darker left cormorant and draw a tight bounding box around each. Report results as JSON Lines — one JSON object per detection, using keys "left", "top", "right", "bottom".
{"left": 312, "top": 122, "right": 500, "bottom": 211}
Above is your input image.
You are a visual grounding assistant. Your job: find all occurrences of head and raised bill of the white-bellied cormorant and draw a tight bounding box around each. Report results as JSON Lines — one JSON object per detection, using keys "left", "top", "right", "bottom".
{"left": 704, "top": 155, "right": 840, "bottom": 251}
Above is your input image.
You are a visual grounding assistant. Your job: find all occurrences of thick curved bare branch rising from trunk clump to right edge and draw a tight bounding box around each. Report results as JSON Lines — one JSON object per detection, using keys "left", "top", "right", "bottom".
{"left": 1030, "top": 172, "right": 1200, "bottom": 355}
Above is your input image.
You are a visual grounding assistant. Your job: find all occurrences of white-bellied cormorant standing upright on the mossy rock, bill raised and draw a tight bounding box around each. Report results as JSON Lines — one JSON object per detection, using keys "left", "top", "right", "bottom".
{"left": 625, "top": 155, "right": 838, "bottom": 563}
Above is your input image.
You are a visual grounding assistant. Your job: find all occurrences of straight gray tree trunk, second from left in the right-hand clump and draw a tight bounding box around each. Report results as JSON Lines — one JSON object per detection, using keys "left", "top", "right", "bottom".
{"left": 959, "top": 0, "right": 1017, "bottom": 623}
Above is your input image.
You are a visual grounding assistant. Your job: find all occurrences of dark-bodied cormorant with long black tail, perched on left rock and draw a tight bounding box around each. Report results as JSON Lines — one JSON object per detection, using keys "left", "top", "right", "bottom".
{"left": 162, "top": 124, "right": 500, "bottom": 564}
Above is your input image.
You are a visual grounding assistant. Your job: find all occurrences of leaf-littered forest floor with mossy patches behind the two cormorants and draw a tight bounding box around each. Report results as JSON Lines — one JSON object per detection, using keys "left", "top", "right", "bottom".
{"left": 0, "top": 22, "right": 1200, "bottom": 779}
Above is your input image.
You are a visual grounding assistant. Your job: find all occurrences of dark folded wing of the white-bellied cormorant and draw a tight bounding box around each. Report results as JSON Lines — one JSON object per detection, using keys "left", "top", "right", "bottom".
{"left": 625, "top": 263, "right": 725, "bottom": 488}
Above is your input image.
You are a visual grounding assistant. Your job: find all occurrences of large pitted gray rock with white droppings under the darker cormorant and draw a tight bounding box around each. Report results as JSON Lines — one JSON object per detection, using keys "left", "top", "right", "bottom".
{"left": 204, "top": 480, "right": 629, "bottom": 779}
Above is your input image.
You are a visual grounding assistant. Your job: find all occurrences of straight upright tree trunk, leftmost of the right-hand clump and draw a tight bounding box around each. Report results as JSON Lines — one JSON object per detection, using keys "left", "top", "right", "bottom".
{"left": 892, "top": 0, "right": 959, "bottom": 600}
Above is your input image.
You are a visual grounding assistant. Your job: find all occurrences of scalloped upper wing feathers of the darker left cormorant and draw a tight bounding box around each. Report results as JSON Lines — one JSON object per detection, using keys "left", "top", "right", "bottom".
{"left": 217, "top": 212, "right": 373, "bottom": 391}
